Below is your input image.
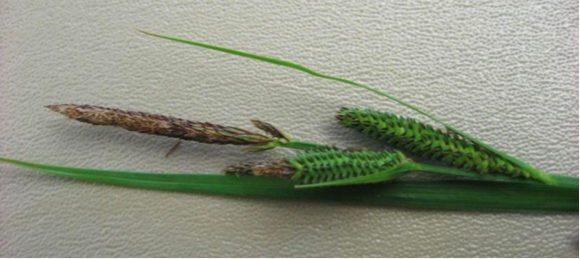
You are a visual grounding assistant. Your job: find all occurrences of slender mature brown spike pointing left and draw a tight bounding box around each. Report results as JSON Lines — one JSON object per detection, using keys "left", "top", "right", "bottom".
{"left": 46, "top": 104, "right": 273, "bottom": 145}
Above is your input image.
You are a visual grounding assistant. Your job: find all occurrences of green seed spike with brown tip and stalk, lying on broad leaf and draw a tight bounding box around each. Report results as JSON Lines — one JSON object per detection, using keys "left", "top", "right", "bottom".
{"left": 224, "top": 149, "right": 578, "bottom": 188}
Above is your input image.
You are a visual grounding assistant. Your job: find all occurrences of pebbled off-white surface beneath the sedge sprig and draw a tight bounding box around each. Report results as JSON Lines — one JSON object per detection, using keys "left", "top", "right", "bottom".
{"left": 0, "top": 0, "right": 579, "bottom": 258}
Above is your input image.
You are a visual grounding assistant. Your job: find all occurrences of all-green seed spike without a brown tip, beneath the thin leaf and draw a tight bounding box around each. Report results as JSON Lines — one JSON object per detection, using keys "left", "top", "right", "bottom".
{"left": 337, "top": 108, "right": 541, "bottom": 180}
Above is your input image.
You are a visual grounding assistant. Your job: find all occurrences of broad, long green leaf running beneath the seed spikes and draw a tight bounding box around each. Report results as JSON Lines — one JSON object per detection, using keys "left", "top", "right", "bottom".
{"left": 0, "top": 158, "right": 579, "bottom": 213}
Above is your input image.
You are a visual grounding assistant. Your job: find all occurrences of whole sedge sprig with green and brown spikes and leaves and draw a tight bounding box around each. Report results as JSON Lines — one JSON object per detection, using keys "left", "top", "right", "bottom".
{"left": 0, "top": 30, "right": 578, "bottom": 213}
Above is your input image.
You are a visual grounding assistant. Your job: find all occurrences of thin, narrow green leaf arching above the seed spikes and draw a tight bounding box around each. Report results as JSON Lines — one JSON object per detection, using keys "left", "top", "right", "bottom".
{"left": 136, "top": 29, "right": 557, "bottom": 184}
